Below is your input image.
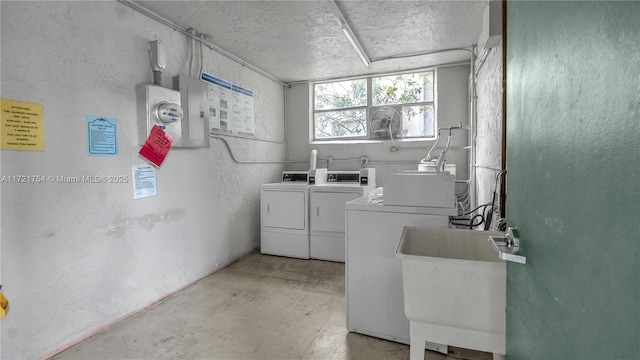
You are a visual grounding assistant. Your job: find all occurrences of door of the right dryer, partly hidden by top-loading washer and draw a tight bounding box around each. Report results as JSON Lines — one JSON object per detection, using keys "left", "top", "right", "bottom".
{"left": 309, "top": 190, "right": 362, "bottom": 232}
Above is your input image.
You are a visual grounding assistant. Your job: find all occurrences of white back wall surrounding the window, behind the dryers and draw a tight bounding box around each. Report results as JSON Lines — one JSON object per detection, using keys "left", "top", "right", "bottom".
{"left": 286, "top": 66, "right": 469, "bottom": 192}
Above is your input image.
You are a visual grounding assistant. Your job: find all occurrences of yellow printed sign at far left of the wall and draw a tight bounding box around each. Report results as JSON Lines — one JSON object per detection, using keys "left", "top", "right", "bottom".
{"left": 0, "top": 99, "right": 44, "bottom": 151}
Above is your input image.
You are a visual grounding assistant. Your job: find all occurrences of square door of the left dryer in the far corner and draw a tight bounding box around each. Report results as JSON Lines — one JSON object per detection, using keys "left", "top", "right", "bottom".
{"left": 260, "top": 190, "right": 307, "bottom": 230}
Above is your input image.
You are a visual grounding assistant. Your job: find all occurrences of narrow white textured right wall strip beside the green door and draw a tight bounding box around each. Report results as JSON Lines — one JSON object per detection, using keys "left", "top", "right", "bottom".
{"left": 475, "top": 43, "right": 503, "bottom": 223}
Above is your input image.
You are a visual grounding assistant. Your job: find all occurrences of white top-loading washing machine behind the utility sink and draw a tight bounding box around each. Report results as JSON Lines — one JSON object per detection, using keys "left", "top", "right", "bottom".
{"left": 345, "top": 186, "right": 458, "bottom": 353}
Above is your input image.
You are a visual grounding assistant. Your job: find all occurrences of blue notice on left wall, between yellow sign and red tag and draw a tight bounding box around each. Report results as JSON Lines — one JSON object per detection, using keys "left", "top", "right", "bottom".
{"left": 87, "top": 115, "right": 118, "bottom": 156}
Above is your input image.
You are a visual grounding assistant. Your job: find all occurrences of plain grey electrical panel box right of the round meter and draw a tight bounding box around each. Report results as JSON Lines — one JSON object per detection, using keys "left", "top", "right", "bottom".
{"left": 173, "top": 75, "right": 210, "bottom": 147}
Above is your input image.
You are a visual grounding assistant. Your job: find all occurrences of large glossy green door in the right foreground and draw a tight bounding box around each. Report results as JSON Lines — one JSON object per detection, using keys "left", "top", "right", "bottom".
{"left": 507, "top": 1, "right": 640, "bottom": 359}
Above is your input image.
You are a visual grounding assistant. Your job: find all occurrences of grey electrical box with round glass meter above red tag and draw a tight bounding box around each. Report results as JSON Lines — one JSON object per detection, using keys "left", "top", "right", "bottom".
{"left": 136, "top": 84, "right": 183, "bottom": 146}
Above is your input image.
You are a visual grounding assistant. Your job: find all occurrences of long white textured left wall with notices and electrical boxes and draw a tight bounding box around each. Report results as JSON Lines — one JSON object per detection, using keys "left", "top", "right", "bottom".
{"left": 0, "top": 1, "right": 285, "bottom": 359}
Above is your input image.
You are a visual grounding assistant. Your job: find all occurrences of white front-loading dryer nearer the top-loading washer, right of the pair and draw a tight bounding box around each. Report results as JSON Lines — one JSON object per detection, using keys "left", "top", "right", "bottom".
{"left": 309, "top": 168, "right": 376, "bottom": 262}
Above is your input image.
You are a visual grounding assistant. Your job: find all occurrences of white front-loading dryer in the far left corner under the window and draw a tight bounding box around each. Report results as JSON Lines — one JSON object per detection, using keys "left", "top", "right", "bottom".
{"left": 260, "top": 169, "right": 326, "bottom": 259}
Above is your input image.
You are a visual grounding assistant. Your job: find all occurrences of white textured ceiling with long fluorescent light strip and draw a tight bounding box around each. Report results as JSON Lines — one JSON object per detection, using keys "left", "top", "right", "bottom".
{"left": 136, "top": 0, "right": 487, "bottom": 82}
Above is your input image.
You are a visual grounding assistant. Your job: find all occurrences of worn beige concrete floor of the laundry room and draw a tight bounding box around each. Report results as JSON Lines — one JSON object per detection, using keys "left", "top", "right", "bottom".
{"left": 51, "top": 252, "right": 492, "bottom": 360}
